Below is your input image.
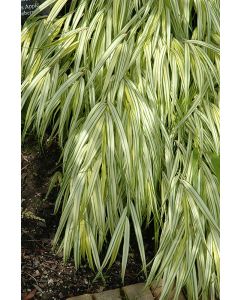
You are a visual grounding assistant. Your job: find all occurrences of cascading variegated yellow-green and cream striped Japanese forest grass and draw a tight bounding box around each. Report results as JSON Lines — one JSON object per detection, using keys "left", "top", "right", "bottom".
{"left": 22, "top": 0, "right": 219, "bottom": 299}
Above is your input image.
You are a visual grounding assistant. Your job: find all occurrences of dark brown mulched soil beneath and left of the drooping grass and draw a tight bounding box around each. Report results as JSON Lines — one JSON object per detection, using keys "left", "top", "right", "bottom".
{"left": 21, "top": 136, "right": 153, "bottom": 300}
